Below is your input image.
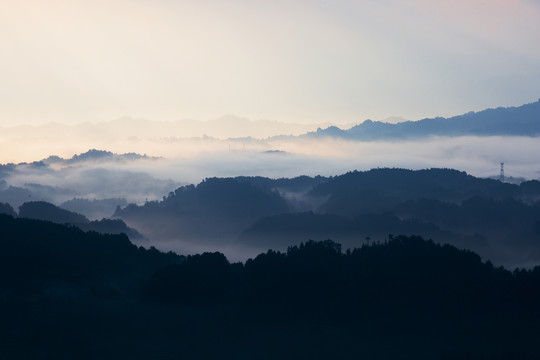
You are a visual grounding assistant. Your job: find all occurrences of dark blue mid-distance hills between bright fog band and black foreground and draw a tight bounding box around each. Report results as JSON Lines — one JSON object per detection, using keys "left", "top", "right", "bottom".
{"left": 115, "top": 169, "right": 540, "bottom": 264}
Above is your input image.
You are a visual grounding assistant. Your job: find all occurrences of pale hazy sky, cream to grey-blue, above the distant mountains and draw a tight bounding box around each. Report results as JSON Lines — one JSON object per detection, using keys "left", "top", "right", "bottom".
{"left": 0, "top": 0, "right": 540, "bottom": 126}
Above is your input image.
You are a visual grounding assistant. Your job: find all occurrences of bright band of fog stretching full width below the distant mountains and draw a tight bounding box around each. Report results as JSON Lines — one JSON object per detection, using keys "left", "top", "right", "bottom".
{"left": 0, "top": 135, "right": 540, "bottom": 179}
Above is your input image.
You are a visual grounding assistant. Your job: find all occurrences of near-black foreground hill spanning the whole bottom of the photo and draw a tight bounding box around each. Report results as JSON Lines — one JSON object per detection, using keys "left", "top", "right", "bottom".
{"left": 0, "top": 215, "right": 540, "bottom": 360}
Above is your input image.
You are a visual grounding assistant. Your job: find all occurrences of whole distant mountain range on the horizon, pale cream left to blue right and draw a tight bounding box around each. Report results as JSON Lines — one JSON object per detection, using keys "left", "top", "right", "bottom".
{"left": 0, "top": 100, "right": 540, "bottom": 144}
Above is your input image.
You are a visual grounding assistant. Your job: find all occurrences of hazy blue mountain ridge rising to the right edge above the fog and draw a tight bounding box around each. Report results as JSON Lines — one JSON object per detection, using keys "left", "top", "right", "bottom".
{"left": 306, "top": 100, "right": 540, "bottom": 140}
